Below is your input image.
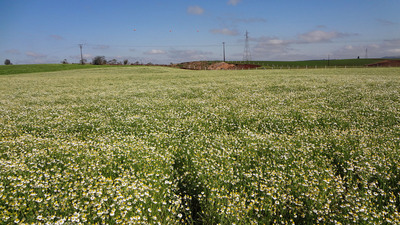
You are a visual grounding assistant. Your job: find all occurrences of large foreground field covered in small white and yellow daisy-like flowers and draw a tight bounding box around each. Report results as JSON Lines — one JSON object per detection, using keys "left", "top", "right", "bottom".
{"left": 0, "top": 66, "right": 400, "bottom": 224}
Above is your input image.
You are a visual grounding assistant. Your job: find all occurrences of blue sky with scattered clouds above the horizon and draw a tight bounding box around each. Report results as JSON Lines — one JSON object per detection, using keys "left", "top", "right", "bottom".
{"left": 0, "top": 0, "right": 400, "bottom": 64}
